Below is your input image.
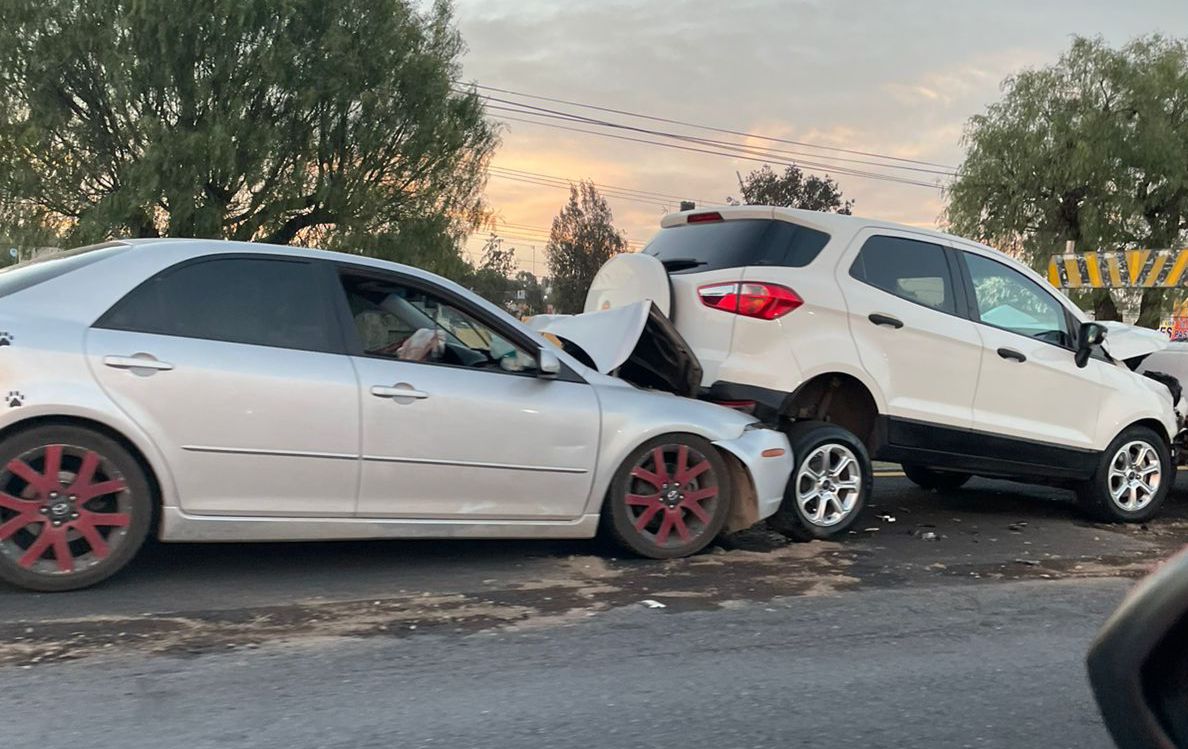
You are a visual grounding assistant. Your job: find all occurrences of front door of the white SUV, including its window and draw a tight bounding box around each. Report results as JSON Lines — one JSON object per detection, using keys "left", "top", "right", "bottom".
{"left": 959, "top": 251, "right": 1102, "bottom": 458}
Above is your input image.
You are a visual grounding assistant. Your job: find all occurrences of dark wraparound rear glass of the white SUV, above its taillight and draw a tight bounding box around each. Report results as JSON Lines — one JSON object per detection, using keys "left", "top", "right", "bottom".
{"left": 644, "top": 219, "right": 829, "bottom": 273}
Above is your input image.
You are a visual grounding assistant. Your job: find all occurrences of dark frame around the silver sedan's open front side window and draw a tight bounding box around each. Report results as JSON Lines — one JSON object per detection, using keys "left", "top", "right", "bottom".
{"left": 328, "top": 262, "right": 587, "bottom": 384}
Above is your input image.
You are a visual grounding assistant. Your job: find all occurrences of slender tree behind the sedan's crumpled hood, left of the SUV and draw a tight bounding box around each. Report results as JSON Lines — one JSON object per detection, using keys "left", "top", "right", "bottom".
{"left": 545, "top": 182, "right": 627, "bottom": 313}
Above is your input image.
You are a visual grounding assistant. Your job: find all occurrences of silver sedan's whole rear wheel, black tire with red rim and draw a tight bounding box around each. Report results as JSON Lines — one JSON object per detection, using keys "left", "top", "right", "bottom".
{"left": 0, "top": 426, "right": 153, "bottom": 592}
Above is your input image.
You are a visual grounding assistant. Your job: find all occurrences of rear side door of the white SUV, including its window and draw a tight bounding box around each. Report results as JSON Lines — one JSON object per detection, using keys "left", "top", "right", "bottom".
{"left": 836, "top": 229, "right": 981, "bottom": 430}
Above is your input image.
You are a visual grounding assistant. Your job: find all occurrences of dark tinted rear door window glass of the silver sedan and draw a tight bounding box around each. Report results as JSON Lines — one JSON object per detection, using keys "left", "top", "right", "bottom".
{"left": 95, "top": 258, "right": 340, "bottom": 352}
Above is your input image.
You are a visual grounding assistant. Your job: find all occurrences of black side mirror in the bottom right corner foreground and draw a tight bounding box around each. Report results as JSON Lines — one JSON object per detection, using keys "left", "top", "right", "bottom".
{"left": 1088, "top": 552, "right": 1188, "bottom": 749}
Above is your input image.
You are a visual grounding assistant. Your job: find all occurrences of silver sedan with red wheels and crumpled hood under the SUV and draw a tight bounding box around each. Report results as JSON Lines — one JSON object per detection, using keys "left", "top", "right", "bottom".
{"left": 0, "top": 240, "right": 791, "bottom": 591}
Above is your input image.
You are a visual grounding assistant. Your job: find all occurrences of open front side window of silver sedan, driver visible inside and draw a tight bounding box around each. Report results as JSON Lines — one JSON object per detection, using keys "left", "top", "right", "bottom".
{"left": 342, "top": 273, "right": 536, "bottom": 372}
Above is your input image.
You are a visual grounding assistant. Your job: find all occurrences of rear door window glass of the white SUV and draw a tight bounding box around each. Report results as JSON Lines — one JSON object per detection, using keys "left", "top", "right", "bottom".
{"left": 849, "top": 237, "right": 956, "bottom": 314}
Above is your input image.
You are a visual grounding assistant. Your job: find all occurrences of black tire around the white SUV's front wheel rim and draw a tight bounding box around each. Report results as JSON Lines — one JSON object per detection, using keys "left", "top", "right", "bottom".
{"left": 1076, "top": 427, "right": 1176, "bottom": 523}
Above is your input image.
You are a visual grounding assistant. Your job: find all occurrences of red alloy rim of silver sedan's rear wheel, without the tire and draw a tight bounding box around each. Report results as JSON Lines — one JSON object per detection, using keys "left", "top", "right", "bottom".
{"left": 0, "top": 445, "right": 132, "bottom": 575}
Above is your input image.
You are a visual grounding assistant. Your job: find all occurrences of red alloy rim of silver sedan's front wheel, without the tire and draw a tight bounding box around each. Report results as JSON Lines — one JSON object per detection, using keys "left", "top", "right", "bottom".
{"left": 626, "top": 445, "right": 720, "bottom": 548}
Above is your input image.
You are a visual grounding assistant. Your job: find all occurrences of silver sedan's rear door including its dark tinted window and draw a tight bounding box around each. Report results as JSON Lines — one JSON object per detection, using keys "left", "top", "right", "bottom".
{"left": 87, "top": 256, "right": 359, "bottom": 516}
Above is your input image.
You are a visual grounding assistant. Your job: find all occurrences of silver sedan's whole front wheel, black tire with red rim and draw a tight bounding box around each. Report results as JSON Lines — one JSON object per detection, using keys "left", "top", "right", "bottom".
{"left": 602, "top": 434, "right": 733, "bottom": 559}
